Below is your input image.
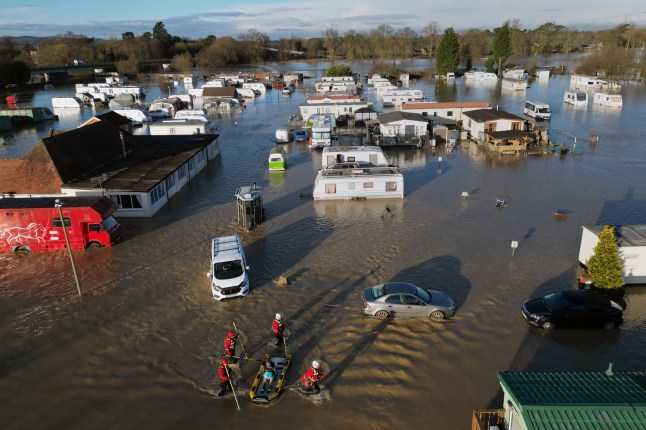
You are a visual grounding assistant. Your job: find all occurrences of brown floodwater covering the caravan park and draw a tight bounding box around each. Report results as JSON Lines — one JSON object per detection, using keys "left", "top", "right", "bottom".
{"left": 0, "top": 63, "right": 646, "bottom": 429}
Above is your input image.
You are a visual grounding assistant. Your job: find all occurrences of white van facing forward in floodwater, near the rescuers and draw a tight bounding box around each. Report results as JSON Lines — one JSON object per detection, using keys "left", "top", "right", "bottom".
{"left": 207, "top": 236, "right": 249, "bottom": 300}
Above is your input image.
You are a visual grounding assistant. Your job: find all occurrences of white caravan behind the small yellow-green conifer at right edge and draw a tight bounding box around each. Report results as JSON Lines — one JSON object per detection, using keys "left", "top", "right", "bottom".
{"left": 579, "top": 225, "right": 646, "bottom": 284}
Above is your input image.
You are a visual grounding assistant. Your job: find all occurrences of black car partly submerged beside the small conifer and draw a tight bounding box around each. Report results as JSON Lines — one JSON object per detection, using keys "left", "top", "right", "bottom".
{"left": 521, "top": 290, "right": 623, "bottom": 330}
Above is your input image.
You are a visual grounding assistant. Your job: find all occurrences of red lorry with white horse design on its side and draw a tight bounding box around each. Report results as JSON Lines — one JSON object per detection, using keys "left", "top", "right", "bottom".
{"left": 0, "top": 197, "right": 121, "bottom": 252}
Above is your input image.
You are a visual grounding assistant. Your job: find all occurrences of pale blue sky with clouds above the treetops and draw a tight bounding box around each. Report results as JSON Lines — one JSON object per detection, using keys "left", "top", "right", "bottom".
{"left": 0, "top": 0, "right": 646, "bottom": 40}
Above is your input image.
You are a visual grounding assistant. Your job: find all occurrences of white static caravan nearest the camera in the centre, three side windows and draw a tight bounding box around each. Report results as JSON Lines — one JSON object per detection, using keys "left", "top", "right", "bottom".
{"left": 312, "top": 167, "right": 404, "bottom": 200}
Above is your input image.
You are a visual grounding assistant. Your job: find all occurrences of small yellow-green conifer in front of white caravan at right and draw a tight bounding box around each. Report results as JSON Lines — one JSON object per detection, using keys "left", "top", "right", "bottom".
{"left": 586, "top": 226, "right": 624, "bottom": 289}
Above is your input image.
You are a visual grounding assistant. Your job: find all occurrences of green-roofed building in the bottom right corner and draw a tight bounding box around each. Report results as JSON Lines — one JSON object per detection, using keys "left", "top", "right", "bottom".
{"left": 471, "top": 365, "right": 646, "bottom": 430}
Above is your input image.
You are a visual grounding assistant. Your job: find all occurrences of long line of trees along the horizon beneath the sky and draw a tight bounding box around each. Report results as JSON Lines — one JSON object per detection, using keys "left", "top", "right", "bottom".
{"left": 0, "top": 20, "right": 646, "bottom": 84}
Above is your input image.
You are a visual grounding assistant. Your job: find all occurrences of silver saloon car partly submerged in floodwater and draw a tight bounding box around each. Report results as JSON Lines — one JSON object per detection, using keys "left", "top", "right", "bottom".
{"left": 361, "top": 282, "right": 455, "bottom": 319}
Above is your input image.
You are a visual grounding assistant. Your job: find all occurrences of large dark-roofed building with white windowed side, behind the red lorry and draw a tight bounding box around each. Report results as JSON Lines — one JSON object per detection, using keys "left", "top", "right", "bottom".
{"left": 0, "top": 121, "right": 220, "bottom": 217}
